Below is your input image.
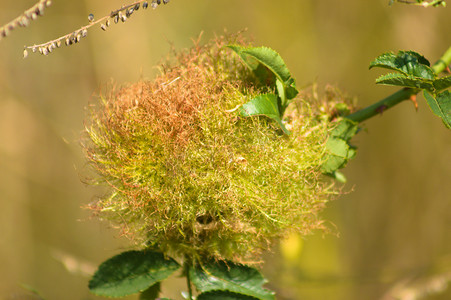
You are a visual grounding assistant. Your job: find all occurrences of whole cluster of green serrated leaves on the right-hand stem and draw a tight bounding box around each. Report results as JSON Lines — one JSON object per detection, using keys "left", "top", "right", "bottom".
{"left": 370, "top": 51, "right": 451, "bottom": 128}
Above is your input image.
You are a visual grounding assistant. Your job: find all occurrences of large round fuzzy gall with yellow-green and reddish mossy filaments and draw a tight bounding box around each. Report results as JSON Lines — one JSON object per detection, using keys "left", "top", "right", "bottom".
{"left": 83, "top": 35, "right": 342, "bottom": 261}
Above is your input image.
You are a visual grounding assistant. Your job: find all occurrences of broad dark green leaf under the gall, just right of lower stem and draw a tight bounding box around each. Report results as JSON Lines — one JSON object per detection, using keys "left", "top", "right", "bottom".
{"left": 189, "top": 261, "right": 275, "bottom": 300}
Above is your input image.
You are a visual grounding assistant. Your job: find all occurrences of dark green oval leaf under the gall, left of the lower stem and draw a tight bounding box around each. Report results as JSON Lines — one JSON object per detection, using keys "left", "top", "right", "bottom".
{"left": 89, "top": 250, "right": 180, "bottom": 297}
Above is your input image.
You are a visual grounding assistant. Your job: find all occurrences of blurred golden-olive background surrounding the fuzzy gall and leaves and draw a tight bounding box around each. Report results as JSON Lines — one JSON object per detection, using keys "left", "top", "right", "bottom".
{"left": 0, "top": 0, "right": 451, "bottom": 300}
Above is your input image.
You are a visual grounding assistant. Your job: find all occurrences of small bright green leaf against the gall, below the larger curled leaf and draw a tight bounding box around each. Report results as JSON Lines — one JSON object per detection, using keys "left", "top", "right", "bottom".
{"left": 240, "top": 94, "right": 290, "bottom": 134}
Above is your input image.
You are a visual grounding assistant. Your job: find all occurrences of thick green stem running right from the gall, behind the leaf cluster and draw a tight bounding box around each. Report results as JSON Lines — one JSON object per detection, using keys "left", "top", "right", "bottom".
{"left": 346, "top": 47, "right": 451, "bottom": 123}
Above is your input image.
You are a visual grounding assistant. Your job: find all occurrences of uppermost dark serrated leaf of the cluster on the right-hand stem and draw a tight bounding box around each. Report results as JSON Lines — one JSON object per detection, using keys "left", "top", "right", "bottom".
{"left": 370, "top": 51, "right": 436, "bottom": 80}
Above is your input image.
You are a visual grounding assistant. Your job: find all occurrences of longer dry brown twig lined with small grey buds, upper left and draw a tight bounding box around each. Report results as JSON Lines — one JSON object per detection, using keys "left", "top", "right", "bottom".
{"left": 24, "top": 0, "right": 169, "bottom": 58}
